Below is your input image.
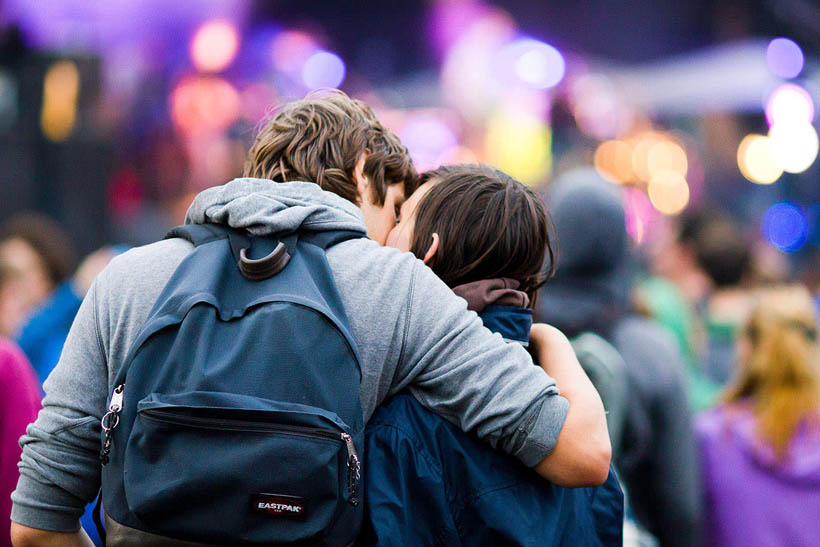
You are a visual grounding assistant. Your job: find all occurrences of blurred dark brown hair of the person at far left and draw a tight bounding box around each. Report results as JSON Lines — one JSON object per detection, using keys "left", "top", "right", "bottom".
{"left": 0, "top": 212, "right": 77, "bottom": 285}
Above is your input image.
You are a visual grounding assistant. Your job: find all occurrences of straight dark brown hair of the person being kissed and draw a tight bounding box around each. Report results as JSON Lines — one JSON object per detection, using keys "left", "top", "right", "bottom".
{"left": 410, "top": 165, "right": 555, "bottom": 301}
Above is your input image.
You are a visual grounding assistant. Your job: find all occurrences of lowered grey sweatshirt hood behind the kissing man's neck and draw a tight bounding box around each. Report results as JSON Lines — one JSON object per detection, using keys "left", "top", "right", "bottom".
{"left": 185, "top": 178, "right": 367, "bottom": 236}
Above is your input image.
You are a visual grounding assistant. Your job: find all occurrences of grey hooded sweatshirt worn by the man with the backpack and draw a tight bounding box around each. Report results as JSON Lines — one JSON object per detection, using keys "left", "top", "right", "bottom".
{"left": 12, "top": 179, "right": 569, "bottom": 531}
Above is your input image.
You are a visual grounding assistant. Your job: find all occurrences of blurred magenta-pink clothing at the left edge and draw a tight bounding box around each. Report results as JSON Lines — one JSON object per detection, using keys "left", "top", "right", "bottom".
{"left": 0, "top": 339, "right": 40, "bottom": 546}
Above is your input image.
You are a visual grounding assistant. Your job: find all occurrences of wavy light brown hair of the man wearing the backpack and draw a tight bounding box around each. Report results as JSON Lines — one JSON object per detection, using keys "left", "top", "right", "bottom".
{"left": 244, "top": 90, "right": 417, "bottom": 205}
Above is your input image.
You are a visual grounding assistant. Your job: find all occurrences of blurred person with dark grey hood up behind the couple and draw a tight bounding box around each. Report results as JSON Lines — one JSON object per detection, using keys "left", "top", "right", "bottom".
{"left": 536, "top": 168, "right": 700, "bottom": 546}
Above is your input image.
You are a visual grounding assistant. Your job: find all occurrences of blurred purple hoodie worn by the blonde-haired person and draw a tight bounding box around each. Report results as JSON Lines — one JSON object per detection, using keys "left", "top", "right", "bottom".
{"left": 697, "top": 405, "right": 820, "bottom": 547}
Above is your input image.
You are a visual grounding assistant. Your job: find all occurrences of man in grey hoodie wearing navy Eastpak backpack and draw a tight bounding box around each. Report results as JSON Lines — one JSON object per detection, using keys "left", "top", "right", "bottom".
{"left": 12, "top": 93, "right": 610, "bottom": 545}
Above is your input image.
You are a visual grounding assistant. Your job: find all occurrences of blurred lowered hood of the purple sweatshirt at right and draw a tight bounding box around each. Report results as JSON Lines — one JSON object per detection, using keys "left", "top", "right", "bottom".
{"left": 704, "top": 405, "right": 820, "bottom": 487}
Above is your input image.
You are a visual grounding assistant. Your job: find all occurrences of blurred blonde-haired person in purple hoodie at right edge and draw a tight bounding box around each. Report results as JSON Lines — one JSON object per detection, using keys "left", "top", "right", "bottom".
{"left": 697, "top": 285, "right": 820, "bottom": 547}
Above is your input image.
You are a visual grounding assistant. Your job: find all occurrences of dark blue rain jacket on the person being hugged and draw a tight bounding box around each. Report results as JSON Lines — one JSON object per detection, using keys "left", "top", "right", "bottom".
{"left": 360, "top": 306, "right": 624, "bottom": 546}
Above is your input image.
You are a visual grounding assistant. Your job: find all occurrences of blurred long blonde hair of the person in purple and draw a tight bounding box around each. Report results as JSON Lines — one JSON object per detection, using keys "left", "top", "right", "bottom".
{"left": 724, "top": 285, "right": 820, "bottom": 458}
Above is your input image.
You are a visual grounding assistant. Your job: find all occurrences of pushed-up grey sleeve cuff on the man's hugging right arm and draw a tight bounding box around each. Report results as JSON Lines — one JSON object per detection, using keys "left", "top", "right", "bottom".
{"left": 513, "top": 395, "right": 569, "bottom": 467}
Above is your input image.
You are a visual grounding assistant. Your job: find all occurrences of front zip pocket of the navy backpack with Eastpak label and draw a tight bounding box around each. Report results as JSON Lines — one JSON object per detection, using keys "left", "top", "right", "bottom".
{"left": 124, "top": 392, "right": 358, "bottom": 543}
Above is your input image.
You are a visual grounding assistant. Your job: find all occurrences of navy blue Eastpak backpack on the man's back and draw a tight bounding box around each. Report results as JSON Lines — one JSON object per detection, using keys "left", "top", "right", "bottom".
{"left": 101, "top": 225, "right": 363, "bottom": 545}
